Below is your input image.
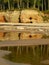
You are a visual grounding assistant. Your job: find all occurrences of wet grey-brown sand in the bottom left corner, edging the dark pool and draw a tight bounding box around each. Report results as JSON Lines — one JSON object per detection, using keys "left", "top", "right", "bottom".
{"left": 0, "top": 50, "right": 30, "bottom": 65}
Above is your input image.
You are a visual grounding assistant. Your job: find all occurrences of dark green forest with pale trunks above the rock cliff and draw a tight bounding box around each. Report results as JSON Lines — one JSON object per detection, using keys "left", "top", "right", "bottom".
{"left": 0, "top": 0, "right": 49, "bottom": 10}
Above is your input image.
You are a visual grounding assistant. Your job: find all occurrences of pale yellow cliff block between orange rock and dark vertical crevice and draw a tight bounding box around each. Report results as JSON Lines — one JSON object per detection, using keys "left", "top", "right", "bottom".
{"left": 4, "top": 11, "right": 20, "bottom": 23}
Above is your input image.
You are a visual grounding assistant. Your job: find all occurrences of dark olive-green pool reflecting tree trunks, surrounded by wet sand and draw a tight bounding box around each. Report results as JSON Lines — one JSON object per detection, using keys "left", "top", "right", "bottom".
{"left": 0, "top": 45, "right": 49, "bottom": 65}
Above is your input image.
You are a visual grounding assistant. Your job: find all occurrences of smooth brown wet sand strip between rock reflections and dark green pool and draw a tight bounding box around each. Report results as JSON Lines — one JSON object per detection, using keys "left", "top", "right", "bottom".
{"left": 0, "top": 39, "right": 49, "bottom": 47}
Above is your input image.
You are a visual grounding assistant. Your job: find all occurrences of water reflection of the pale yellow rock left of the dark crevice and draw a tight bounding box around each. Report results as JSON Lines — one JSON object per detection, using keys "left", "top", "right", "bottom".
{"left": 4, "top": 32, "right": 19, "bottom": 40}
